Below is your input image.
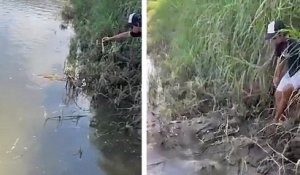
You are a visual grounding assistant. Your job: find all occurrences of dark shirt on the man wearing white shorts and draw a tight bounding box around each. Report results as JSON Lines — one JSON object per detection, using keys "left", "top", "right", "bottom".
{"left": 276, "top": 39, "right": 300, "bottom": 77}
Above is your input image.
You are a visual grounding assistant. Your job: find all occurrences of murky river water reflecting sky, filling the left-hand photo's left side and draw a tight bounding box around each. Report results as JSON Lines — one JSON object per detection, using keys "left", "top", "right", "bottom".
{"left": 0, "top": 0, "right": 141, "bottom": 175}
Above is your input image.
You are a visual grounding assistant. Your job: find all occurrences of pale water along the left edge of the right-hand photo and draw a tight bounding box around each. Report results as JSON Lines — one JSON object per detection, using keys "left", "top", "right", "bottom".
{"left": 146, "top": 55, "right": 194, "bottom": 175}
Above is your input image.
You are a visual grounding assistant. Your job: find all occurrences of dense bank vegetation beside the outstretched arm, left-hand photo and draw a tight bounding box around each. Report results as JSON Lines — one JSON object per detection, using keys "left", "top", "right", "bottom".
{"left": 62, "top": 0, "right": 141, "bottom": 129}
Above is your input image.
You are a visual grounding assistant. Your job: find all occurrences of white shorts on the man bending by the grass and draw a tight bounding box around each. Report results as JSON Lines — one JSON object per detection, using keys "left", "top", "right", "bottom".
{"left": 276, "top": 71, "right": 300, "bottom": 92}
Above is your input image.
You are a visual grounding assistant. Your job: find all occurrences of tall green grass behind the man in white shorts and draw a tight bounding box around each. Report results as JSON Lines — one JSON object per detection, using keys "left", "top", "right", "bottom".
{"left": 148, "top": 0, "right": 300, "bottom": 119}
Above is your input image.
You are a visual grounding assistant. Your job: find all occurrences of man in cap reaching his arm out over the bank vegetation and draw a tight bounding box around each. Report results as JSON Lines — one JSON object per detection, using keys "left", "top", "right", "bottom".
{"left": 102, "top": 13, "right": 142, "bottom": 42}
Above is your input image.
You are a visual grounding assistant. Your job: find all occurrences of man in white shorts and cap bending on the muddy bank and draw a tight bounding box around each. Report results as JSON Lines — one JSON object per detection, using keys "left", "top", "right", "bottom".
{"left": 265, "top": 21, "right": 300, "bottom": 122}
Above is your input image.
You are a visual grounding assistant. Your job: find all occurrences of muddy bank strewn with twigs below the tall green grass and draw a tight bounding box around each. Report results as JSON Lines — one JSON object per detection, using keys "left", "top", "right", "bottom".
{"left": 148, "top": 106, "right": 300, "bottom": 175}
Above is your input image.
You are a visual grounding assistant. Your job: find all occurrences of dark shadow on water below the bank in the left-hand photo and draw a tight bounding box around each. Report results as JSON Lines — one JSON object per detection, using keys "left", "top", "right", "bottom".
{"left": 91, "top": 98, "right": 141, "bottom": 175}
